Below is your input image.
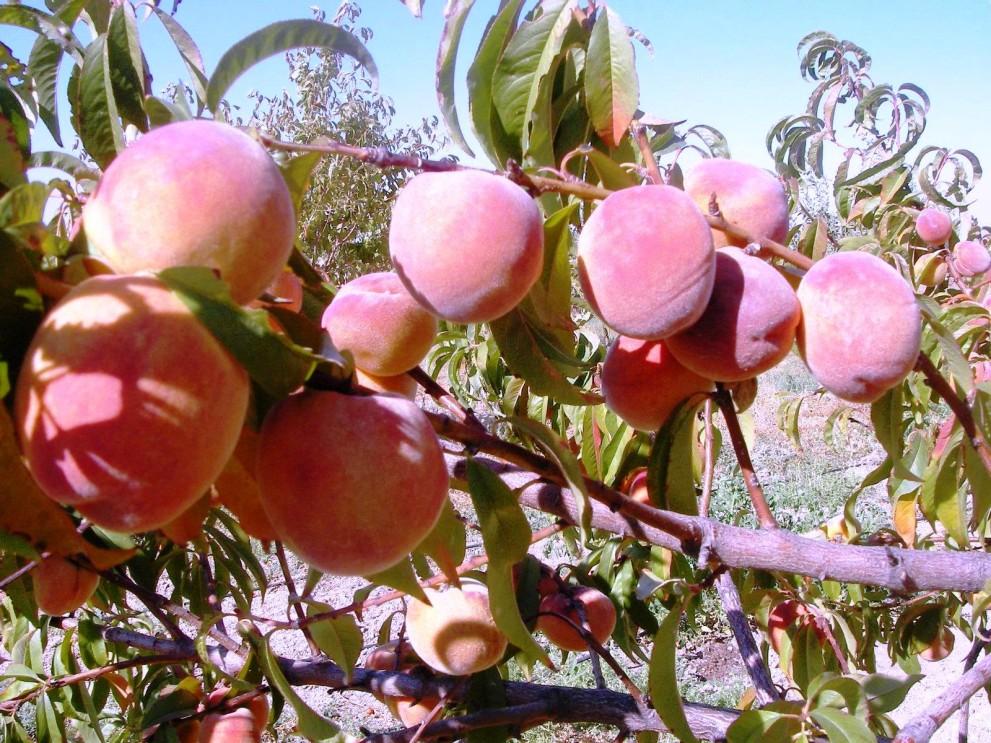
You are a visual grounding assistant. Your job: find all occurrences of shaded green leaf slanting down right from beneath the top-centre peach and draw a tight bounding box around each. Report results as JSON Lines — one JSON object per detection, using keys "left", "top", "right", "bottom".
{"left": 489, "top": 308, "right": 602, "bottom": 405}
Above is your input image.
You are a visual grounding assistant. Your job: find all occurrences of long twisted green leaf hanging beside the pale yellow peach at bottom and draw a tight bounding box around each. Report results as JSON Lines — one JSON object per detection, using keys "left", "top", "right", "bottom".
{"left": 468, "top": 459, "right": 553, "bottom": 667}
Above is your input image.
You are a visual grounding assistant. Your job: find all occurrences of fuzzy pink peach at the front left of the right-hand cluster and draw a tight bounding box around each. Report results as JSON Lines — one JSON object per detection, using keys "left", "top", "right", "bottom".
{"left": 578, "top": 186, "right": 716, "bottom": 340}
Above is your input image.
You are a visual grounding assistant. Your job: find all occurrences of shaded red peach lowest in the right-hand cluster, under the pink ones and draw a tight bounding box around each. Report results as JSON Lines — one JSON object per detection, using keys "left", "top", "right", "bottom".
{"left": 601, "top": 336, "right": 713, "bottom": 431}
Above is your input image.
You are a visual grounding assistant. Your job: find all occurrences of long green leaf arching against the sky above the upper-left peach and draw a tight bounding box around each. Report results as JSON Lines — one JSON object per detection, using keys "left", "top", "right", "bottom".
{"left": 206, "top": 20, "right": 378, "bottom": 111}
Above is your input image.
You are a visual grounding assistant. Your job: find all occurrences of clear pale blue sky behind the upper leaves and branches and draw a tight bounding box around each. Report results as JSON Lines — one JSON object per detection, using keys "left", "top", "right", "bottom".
{"left": 7, "top": 0, "right": 991, "bottom": 222}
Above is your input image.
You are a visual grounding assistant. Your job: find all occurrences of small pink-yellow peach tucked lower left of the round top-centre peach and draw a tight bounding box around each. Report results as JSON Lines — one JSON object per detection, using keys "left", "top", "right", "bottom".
{"left": 320, "top": 273, "right": 437, "bottom": 377}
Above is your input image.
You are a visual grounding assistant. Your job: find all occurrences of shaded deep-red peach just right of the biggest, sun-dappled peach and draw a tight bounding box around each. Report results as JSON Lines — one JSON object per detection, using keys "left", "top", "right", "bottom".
{"left": 256, "top": 390, "right": 448, "bottom": 575}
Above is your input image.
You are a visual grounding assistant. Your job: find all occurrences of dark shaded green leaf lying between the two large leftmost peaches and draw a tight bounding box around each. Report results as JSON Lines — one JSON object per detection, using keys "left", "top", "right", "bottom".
{"left": 158, "top": 268, "right": 320, "bottom": 399}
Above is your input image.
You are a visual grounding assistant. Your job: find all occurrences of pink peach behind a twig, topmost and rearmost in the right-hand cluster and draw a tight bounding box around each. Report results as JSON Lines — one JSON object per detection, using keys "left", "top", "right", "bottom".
{"left": 685, "top": 158, "right": 788, "bottom": 248}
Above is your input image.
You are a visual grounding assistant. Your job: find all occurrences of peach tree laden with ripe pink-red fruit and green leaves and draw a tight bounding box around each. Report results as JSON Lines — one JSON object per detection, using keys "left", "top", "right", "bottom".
{"left": 0, "top": 0, "right": 991, "bottom": 743}
